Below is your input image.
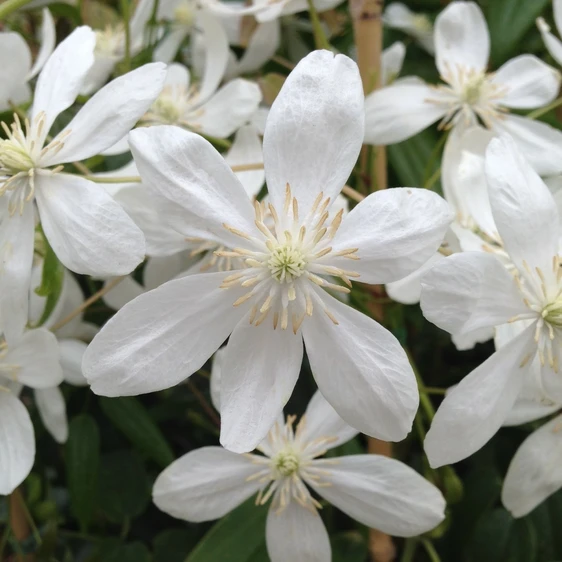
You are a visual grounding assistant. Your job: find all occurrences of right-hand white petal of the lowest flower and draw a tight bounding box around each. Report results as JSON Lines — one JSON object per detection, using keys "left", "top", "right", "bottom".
{"left": 310, "top": 455, "right": 445, "bottom": 537}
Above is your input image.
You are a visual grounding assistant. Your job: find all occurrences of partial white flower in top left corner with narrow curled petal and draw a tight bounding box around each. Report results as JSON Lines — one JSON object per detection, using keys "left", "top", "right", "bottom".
{"left": 0, "top": 8, "right": 56, "bottom": 111}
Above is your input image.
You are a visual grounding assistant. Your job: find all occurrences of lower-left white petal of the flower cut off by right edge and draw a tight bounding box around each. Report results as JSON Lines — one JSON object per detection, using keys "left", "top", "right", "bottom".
{"left": 424, "top": 326, "right": 536, "bottom": 468}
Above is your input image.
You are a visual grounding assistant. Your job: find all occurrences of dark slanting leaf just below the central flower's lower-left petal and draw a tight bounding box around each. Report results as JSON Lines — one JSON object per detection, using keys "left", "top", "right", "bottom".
{"left": 100, "top": 397, "right": 174, "bottom": 468}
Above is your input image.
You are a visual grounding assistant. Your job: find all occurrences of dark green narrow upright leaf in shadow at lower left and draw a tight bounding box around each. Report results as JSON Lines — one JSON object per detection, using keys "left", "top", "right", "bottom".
{"left": 66, "top": 414, "right": 100, "bottom": 531}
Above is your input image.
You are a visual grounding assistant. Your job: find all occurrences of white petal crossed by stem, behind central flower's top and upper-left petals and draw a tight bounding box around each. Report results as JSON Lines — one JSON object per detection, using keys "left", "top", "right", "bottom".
{"left": 224, "top": 125, "right": 265, "bottom": 198}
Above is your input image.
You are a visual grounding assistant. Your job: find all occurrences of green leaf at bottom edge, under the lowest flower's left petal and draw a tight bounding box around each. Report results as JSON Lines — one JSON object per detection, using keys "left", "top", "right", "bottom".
{"left": 186, "top": 498, "right": 269, "bottom": 562}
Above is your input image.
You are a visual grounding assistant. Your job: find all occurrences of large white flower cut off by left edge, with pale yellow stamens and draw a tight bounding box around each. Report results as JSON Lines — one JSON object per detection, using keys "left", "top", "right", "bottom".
{"left": 0, "top": 27, "right": 165, "bottom": 341}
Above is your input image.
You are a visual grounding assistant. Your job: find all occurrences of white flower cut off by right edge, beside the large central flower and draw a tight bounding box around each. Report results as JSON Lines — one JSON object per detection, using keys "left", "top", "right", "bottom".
{"left": 421, "top": 136, "right": 562, "bottom": 466}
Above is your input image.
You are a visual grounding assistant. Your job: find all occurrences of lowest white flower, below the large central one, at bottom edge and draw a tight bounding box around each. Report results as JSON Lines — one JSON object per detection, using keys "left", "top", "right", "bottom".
{"left": 153, "top": 393, "right": 445, "bottom": 562}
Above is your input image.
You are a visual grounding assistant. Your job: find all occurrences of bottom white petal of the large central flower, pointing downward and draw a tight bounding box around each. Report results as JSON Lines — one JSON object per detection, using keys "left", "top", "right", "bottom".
{"left": 220, "top": 312, "right": 303, "bottom": 453}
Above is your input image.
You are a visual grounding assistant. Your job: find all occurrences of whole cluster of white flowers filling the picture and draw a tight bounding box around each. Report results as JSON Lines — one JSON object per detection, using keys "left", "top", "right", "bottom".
{"left": 0, "top": 0, "right": 562, "bottom": 552}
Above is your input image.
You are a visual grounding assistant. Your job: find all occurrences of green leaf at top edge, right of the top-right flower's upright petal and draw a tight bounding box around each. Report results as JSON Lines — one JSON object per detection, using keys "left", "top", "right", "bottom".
{"left": 487, "top": 0, "right": 550, "bottom": 68}
